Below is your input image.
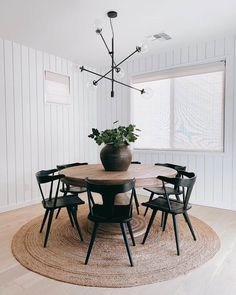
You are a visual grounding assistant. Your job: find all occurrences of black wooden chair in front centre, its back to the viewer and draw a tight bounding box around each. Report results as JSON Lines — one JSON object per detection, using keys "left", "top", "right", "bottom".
{"left": 85, "top": 179, "right": 135, "bottom": 266}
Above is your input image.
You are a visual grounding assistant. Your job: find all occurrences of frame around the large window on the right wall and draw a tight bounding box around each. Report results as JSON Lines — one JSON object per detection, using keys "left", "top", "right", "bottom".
{"left": 130, "top": 58, "right": 227, "bottom": 155}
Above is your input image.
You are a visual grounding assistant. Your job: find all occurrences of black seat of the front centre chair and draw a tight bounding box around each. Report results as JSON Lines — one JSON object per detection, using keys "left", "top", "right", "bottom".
{"left": 88, "top": 204, "right": 132, "bottom": 223}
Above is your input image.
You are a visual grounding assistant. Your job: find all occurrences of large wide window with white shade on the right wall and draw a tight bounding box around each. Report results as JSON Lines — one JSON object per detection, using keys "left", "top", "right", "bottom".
{"left": 131, "top": 62, "right": 225, "bottom": 152}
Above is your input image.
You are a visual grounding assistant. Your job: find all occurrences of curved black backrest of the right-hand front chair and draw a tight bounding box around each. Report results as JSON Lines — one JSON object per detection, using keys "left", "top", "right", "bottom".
{"left": 157, "top": 171, "right": 197, "bottom": 209}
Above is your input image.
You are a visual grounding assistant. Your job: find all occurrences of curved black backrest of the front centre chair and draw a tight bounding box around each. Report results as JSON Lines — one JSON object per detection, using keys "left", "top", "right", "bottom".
{"left": 86, "top": 178, "right": 135, "bottom": 219}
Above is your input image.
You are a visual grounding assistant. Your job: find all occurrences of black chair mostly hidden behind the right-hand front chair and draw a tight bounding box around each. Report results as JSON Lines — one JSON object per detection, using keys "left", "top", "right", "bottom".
{"left": 143, "top": 163, "right": 186, "bottom": 219}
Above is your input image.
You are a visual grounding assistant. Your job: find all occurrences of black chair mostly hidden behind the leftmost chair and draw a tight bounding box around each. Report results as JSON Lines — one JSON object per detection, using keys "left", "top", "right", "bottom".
{"left": 56, "top": 162, "right": 88, "bottom": 219}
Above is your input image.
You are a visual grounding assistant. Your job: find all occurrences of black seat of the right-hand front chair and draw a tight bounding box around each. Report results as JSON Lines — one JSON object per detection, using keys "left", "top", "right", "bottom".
{"left": 142, "top": 197, "right": 192, "bottom": 214}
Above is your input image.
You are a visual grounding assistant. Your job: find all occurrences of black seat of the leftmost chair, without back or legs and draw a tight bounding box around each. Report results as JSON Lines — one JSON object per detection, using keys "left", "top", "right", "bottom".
{"left": 42, "top": 195, "right": 85, "bottom": 209}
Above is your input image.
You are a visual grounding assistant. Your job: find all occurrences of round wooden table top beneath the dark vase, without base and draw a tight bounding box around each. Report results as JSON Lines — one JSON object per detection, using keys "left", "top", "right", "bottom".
{"left": 60, "top": 164, "right": 177, "bottom": 187}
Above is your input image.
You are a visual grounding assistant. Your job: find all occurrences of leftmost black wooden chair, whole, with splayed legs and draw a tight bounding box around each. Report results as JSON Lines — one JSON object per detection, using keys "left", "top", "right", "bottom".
{"left": 36, "top": 169, "right": 85, "bottom": 247}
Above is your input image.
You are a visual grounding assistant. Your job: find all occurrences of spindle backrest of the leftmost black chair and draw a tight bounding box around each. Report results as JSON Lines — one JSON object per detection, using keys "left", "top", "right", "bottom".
{"left": 35, "top": 169, "right": 65, "bottom": 207}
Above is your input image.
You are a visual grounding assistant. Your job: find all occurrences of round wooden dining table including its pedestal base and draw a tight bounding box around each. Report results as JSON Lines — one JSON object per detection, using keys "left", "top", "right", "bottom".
{"left": 60, "top": 164, "right": 177, "bottom": 238}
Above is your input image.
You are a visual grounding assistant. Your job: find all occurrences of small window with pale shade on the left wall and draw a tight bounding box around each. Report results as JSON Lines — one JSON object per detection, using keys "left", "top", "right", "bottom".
{"left": 45, "top": 71, "right": 71, "bottom": 104}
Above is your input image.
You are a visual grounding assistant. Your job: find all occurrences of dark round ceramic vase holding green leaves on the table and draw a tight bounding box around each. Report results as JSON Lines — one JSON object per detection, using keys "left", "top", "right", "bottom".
{"left": 100, "top": 144, "right": 132, "bottom": 171}
